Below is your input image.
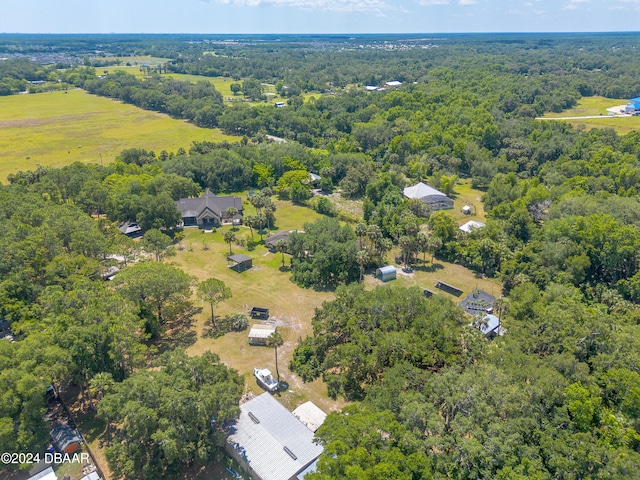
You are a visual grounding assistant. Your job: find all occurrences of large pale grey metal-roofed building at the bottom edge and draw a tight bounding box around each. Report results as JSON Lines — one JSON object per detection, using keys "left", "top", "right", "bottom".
{"left": 227, "top": 393, "right": 323, "bottom": 480}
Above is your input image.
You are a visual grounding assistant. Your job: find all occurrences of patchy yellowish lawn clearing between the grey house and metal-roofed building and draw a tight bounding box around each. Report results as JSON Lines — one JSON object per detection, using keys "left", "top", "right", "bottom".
{"left": 168, "top": 201, "right": 344, "bottom": 412}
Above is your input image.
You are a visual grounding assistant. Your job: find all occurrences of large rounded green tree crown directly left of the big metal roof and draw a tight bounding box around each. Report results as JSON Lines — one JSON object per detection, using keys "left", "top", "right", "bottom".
{"left": 99, "top": 351, "right": 243, "bottom": 479}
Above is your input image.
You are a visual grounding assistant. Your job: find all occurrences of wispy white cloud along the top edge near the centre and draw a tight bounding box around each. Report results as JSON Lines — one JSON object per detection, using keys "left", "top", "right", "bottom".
{"left": 208, "top": 0, "right": 391, "bottom": 14}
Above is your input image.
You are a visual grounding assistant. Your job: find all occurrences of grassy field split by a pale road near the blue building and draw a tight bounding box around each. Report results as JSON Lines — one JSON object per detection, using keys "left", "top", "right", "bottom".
{"left": 543, "top": 97, "right": 640, "bottom": 135}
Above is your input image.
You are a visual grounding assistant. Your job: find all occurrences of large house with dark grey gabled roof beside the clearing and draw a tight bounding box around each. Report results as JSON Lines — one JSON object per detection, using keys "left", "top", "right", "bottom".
{"left": 176, "top": 189, "right": 242, "bottom": 228}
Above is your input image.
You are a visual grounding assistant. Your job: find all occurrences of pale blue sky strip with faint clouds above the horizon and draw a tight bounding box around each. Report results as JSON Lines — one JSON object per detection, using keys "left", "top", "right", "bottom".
{"left": 0, "top": 0, "right": 640, "bottom": 34}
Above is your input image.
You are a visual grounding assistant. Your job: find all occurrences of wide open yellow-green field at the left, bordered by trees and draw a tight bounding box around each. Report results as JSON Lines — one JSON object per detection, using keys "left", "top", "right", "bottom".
{"left": 0, "top": 90, "right": 237, "bottom": 182}
